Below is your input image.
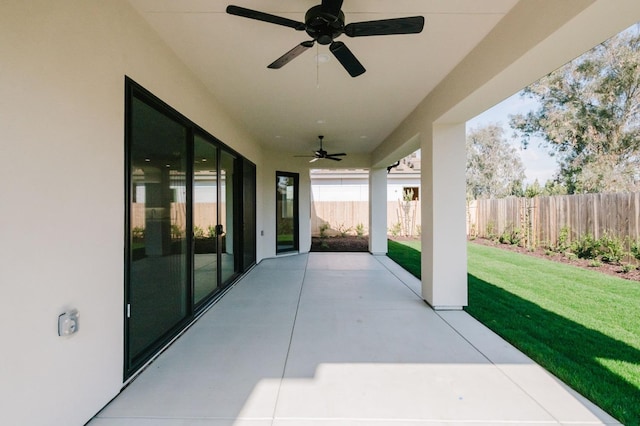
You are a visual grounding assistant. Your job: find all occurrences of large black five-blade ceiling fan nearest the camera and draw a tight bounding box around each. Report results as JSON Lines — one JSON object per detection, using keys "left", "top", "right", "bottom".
{"left": 227, "top": 0, "right": 424, "bottom": 77}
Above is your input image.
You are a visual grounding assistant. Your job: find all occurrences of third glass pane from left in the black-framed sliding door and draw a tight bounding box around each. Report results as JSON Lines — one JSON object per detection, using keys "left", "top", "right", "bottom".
{"left": 219, "top": 151, "right": 238, "bottom": 283}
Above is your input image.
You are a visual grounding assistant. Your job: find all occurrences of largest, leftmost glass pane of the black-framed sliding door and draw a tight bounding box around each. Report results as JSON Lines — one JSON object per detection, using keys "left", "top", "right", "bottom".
{"left": 127, "top": 98, "right": 190, "bottom": 366}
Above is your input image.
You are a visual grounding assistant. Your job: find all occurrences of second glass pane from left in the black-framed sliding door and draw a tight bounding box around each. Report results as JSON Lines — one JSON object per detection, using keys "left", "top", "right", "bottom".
{"left": 193, "top": 135, "right": 218, "bottom": 304}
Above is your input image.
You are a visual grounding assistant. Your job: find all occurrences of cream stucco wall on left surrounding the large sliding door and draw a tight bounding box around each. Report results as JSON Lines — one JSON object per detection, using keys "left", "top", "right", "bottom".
{"left": 0, "top": 0, "right": 264, "bottom": 425}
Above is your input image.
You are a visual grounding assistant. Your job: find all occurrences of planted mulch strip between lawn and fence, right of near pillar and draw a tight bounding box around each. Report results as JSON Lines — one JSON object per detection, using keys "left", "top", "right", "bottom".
{"left": 471, "top": 238, "right": 640, "bottom": 281}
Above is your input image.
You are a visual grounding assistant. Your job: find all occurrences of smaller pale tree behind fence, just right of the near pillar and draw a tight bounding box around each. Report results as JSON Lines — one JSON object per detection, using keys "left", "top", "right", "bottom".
{"left": 467, "top": 124, "right": 525, "bottom": 199}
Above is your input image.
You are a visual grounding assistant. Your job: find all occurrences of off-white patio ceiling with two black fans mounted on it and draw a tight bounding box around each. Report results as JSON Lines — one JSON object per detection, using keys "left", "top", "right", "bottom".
{"left": 129, "top": 0, "right": 517, "bottom": 153}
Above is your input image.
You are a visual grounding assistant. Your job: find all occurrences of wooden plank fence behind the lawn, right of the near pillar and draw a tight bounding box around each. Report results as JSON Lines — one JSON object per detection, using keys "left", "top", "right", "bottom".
{"left": 467, "top": 192, "right": 640, "bottom": 246}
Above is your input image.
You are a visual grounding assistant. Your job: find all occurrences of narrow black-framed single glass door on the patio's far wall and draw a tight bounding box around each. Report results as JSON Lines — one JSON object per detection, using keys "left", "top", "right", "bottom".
{"left": 276, "top": 172, "right": 298, "bottom": 253}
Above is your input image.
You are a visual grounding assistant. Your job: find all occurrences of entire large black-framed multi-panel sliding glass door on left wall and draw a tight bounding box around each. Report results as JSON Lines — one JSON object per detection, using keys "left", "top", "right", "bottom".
{"left": 125, "top": 80, "right": 255, "bottom": 377}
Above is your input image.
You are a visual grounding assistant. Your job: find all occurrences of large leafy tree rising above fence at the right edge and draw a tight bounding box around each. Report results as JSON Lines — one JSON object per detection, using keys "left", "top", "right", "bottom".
{"left": 510, "top": 26, "right": 640, "bottom": 193}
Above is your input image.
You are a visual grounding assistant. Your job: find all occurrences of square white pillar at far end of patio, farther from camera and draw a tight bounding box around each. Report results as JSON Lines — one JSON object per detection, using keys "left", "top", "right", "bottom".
{"left": 369, "top": 168, "right": 387, "bottom": 255}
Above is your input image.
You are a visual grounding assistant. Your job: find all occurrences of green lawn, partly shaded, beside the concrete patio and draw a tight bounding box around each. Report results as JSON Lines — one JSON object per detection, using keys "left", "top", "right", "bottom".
{"left": 389, "top": 241, "right": 640, "bottom": 426}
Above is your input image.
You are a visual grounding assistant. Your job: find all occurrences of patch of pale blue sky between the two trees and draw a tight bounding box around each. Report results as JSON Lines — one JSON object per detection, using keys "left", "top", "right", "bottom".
{"left": 467, "top": 93, "right": 558, "bottom": 185}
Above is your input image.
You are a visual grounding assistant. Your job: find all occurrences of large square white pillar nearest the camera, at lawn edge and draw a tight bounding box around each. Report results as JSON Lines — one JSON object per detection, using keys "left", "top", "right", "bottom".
{"left": 420, "top": 123, "right": 468, "bottom": 310}
